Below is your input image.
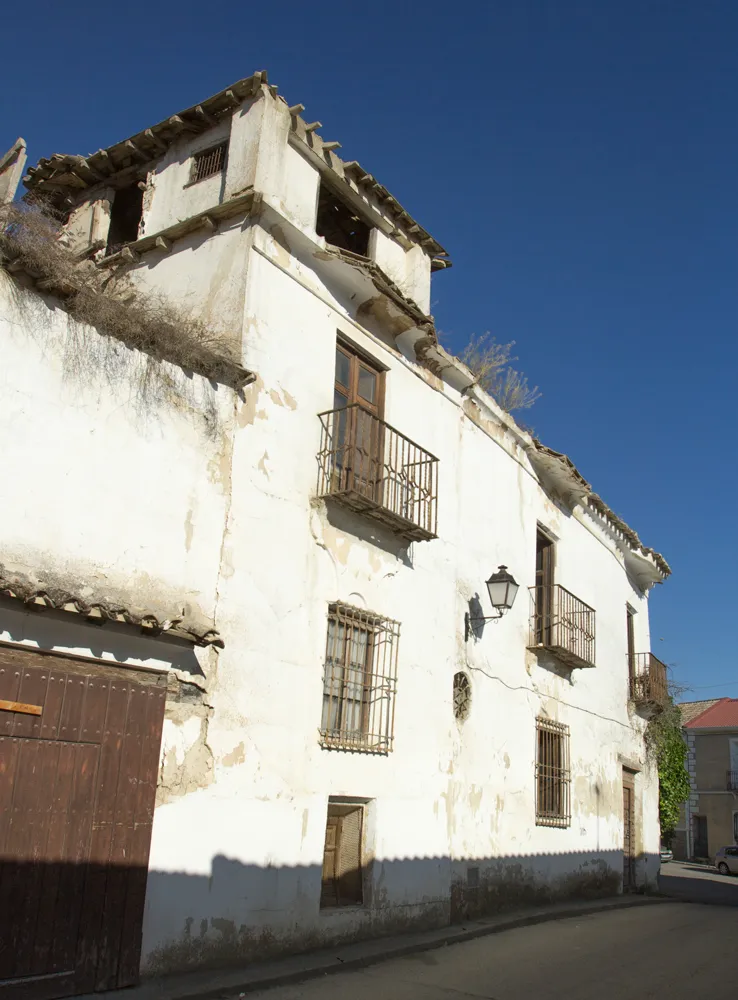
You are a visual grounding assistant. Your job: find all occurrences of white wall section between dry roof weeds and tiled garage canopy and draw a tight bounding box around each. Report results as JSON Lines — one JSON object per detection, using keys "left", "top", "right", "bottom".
{"left": 0, "top": 272, "right": 236, "bottom": 632}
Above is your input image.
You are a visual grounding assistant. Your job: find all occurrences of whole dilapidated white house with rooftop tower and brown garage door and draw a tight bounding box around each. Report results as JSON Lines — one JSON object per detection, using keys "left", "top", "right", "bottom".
{"left": 0, "top": 74, "right": 669, "bottom": 1000}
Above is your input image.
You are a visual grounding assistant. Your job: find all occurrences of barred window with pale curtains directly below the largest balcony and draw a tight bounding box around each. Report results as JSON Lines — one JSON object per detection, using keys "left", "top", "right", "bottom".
{"left": 320, "top": 604, "right": 400, "bottom": 753}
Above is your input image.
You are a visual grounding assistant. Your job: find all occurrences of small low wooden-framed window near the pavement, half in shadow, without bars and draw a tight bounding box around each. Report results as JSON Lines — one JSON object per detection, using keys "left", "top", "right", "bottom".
{"left": 320, "top": 801, "right": 364, "bottom": 908}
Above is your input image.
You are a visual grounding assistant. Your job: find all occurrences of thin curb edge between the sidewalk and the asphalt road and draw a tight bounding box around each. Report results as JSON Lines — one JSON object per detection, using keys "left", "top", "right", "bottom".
{"left": 172, "top": 894, "right": 673, "bottom": 1000}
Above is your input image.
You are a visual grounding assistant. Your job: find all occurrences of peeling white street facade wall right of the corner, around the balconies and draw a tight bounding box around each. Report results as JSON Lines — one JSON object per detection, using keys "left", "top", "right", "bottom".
{"left": 137, "top": 230, "right": 659, "bottom": 972}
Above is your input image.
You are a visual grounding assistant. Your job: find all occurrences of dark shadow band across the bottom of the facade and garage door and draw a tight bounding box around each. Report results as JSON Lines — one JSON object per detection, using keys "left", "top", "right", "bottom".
{"left": 0, "top": 848, "right": 660, "bottom": 1000}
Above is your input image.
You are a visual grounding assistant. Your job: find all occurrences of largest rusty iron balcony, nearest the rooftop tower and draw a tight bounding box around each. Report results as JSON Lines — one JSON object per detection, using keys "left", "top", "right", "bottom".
{"left": 318, "top": 403, "right": 438, "bottom": 541}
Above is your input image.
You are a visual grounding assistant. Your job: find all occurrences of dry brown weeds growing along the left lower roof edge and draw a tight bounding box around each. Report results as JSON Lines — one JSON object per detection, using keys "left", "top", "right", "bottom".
{"left": 0, "top": 204, "right": 248, "bottom": 388}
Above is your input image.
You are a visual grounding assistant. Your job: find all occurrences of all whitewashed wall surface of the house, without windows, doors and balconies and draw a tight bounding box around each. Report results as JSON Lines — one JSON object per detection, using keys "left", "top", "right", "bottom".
{"left": 0, "top": 86, "right": 659, "bottom": 972}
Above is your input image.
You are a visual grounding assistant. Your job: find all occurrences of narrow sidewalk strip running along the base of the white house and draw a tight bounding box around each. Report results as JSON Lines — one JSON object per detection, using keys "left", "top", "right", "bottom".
{"left": 76, "top": 896, "right": 671, "bottom": 1000}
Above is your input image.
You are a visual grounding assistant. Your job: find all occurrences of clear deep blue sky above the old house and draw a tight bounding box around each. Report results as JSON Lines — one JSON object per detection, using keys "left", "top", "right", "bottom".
{"left": 0, "top": 0, "right": 738, "bottom": 697}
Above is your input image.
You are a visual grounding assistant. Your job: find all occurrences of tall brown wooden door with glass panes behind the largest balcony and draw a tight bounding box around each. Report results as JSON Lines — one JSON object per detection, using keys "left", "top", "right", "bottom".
{"left": 333, "top": 343, "right": 384, "bottom": 503}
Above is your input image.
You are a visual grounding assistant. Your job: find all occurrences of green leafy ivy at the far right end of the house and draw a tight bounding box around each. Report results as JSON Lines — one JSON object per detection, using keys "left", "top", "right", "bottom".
{"left": 645, "top": 699, "right": 689, "bottom": 844}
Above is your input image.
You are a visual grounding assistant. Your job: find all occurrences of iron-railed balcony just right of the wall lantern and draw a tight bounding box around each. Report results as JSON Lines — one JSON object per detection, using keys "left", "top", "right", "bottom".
{"left": 528, "top": 584, "right": 595, "bottom": 667}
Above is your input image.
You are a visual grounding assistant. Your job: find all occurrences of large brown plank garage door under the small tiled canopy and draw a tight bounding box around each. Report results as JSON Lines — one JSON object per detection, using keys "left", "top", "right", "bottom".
{"left": 0, "top": 647, "right": 166, "bottom": 1000}
